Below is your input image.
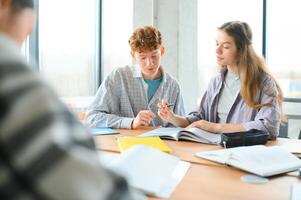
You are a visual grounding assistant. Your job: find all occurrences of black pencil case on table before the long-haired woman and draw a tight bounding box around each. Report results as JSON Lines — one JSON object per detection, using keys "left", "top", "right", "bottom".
{"left": 220, "top": 129, "right": 269, "bottom": 148}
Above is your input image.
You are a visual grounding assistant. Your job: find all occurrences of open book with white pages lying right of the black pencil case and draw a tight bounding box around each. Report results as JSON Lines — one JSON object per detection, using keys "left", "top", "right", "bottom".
{"left": 195, "top": 145, "right": 301, "bottom": 176}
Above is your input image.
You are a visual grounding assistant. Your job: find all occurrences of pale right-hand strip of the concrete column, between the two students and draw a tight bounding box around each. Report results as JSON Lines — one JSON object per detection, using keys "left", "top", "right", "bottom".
{"left": 178, "top": 0, "right": 199, "bottom": 112}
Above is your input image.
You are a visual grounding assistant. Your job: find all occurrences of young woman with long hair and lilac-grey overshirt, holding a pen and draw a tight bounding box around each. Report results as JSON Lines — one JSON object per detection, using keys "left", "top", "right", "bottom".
{"left": 158, "top": 21, "right": 283, "bottom": 139}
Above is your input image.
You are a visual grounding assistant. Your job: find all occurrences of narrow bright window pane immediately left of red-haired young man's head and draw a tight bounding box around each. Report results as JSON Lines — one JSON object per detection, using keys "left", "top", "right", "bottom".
{"left": 102, "top": 0, "right": 133, "bottom": 77}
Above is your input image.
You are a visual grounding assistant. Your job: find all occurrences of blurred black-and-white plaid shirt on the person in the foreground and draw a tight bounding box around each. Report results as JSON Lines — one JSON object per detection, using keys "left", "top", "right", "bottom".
{"left": 0, "top": 33, "right": 141, "bottom": 200}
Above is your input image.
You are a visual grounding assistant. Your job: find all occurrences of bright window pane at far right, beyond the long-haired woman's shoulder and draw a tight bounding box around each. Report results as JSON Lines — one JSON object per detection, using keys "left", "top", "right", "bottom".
{"left": 267, "top": 0, "right": 301, "bottom": 98}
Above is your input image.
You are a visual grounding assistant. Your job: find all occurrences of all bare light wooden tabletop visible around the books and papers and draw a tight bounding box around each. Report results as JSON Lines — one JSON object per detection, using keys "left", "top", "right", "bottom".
{"left": 94, "top": 129, "right": 301, "bottom": 200}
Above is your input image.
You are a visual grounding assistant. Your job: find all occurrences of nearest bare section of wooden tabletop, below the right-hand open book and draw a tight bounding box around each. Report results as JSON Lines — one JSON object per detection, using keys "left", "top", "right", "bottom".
{"left": 155, "top": 164, "right": 301, "bottom": 200}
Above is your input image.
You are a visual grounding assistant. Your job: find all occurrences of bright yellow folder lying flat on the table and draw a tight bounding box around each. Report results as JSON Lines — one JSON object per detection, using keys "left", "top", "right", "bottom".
{"left": 117, "top": 137, "right": 171, "bottom": 153}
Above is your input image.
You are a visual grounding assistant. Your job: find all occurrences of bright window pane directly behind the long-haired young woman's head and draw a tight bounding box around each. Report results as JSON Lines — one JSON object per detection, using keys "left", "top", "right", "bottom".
{"left": 198, "top": 0, "right": 263, "bottom": 96}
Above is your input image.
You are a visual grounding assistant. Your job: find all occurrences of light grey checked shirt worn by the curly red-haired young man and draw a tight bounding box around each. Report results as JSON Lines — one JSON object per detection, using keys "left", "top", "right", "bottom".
{"left": 86, "top": 65, "right": 185, "bottom": 129}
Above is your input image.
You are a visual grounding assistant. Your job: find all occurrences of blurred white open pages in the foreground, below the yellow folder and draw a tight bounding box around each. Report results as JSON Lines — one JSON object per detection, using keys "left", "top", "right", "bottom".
{"left": 101, "top": 145, "right": 190, "bottom": 198}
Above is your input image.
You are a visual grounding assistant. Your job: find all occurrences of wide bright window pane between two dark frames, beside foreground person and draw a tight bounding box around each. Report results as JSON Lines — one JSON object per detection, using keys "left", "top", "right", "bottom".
{"left": 39, "top": 0, "right": 100, "bottom": 97}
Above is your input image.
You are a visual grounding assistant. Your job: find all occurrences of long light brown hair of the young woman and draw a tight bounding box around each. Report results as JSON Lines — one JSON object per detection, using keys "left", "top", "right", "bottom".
{"left": 218, "top": 21, "right": 286, "bottom": 122}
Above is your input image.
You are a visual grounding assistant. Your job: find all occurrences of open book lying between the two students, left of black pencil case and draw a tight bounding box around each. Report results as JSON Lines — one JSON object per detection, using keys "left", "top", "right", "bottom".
{"left": 140, "top": 128, "right": 221, "bottom": 144}
